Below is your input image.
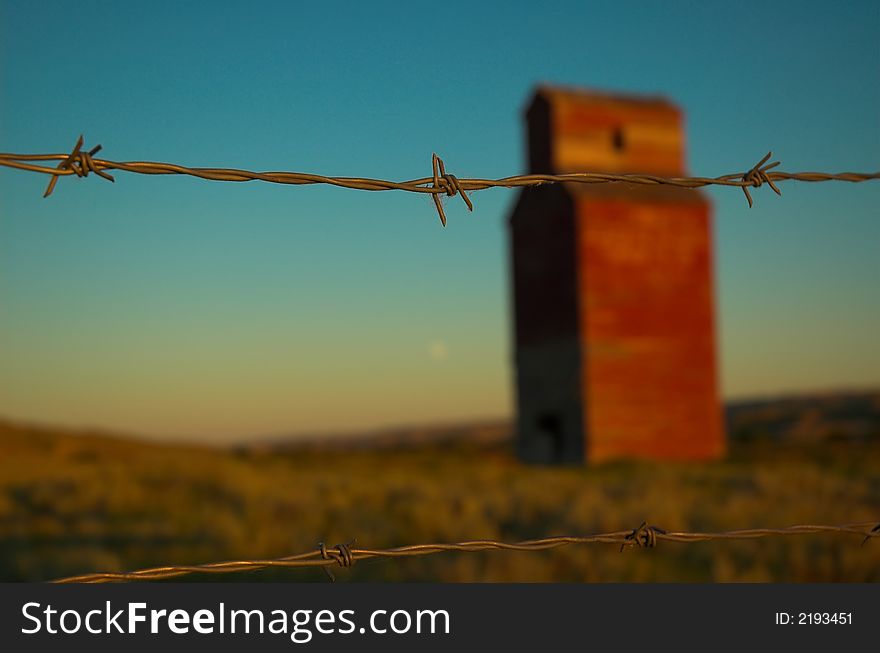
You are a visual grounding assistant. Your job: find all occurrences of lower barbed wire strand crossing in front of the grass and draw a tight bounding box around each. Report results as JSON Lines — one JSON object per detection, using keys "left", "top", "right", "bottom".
{"left": 52, "top": 522, "right": 880, "bottom": 583}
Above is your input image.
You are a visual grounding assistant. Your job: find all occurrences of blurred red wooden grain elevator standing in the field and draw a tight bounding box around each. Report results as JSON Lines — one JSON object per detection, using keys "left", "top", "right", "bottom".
{"left": 510, "top": 87, "right": 725, "bottom": 463}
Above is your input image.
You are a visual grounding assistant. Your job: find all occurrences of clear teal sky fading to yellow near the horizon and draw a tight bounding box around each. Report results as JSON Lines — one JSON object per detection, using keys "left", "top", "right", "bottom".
{"left": 0, "top": 0, "right": 880, "bottom": 442}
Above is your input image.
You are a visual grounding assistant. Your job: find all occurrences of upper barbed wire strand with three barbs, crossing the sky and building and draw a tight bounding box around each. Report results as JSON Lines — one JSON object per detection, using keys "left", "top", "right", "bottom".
{"left": 0, "top": 135, "right": 880, "bottom": 226}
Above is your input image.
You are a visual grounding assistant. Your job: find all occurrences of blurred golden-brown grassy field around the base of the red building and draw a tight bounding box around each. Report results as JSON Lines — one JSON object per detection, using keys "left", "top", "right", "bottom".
{"left": 0, "top": 424, "right": 880, "bottom": 582}
